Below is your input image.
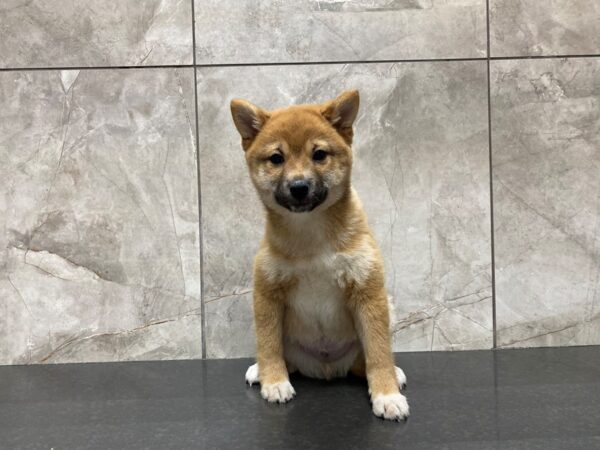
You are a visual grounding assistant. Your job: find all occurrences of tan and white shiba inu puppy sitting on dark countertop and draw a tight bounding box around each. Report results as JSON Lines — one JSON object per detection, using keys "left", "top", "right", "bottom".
{"left": 231, "top": 91, "right": 409, "bottom": 420}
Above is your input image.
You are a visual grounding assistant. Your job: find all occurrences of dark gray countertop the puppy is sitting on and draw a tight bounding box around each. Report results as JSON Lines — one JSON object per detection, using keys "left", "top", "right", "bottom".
{"left": 0, "top": 347, "right": 600, "bottom": 450}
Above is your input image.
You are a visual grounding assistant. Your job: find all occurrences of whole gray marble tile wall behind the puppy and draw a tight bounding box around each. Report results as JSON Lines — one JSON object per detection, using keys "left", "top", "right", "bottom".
{"left": 0, "top": 0, "right": 600, "bottom": 364}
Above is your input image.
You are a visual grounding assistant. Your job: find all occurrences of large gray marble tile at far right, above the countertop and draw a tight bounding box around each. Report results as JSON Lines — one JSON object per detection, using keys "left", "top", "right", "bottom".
{"left": 491, "top": 58, "right": 600, "bottom": 347}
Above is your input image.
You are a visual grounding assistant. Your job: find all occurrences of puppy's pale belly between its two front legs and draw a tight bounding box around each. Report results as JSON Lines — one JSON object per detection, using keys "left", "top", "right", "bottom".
{"left": 284, "top": 271, "right": 360, "bottom": 378}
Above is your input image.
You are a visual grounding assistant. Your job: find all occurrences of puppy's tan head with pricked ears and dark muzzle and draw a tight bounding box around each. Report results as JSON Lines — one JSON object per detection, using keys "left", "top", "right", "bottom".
{"left": 231, "top": 91, "right": 359, "bottom": 213}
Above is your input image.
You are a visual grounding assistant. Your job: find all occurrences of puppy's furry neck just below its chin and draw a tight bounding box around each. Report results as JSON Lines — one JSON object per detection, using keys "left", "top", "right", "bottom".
{"left": 265, "top": 187, "right": 369, "bottom": 258}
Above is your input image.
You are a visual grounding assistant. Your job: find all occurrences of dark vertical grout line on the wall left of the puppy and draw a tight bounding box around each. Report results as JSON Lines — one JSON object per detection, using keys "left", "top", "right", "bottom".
{"left": 190, "top": 0, "right": 206, "bottom": 359}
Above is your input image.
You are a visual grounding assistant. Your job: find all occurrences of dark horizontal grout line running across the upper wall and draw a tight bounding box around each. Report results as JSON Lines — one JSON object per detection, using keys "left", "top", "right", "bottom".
{"left": 0, "top": 54, "right": 600, "bottom": 72}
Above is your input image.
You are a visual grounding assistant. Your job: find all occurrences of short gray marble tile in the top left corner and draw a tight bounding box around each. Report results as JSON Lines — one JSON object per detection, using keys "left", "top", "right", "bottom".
{"left": 0, "top": 0, "right": 193, "bottom": 68}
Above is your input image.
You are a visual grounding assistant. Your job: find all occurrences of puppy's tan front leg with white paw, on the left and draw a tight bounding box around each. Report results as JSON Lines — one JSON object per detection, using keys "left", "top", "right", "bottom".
{"left": 254, "top": 270, "right": 296, "bottom": 403}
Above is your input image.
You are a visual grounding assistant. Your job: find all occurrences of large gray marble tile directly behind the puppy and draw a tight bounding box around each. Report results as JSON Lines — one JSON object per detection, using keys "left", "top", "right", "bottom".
{"left": 198, "top": 61, "right": 492, "bottom": 358}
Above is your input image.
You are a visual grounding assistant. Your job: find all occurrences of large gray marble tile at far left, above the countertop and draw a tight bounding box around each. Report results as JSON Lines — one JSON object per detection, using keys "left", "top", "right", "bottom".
{"left": 0, "top": 68, "right": 201, "bottom": 364}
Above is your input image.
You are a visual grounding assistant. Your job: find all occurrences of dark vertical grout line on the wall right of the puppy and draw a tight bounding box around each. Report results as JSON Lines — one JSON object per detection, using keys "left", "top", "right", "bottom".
{"left": 485, "top": 0, "right": 497, "bottom": 349}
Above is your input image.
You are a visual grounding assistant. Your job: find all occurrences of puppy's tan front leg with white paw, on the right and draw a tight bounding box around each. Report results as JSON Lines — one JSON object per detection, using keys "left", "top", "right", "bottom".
{"left": 350, "top": 283, "right": 409, "bottom": 420}
